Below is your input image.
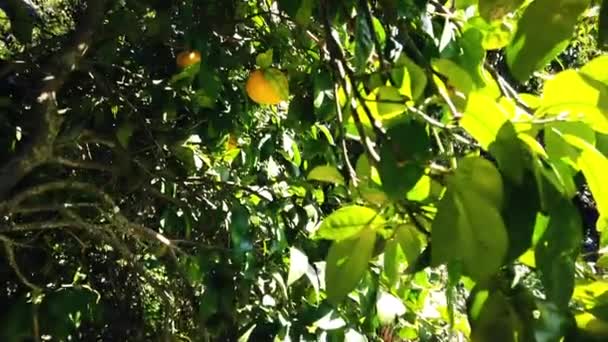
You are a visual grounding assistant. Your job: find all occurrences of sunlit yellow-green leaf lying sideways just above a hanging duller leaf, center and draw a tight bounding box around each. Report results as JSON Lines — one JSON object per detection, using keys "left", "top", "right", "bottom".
{"left": 315, "top": 205, "right": 385, "bottom": 241}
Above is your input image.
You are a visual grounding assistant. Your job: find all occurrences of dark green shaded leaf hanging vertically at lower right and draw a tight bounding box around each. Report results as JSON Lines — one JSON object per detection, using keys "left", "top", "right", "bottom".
{"left": 534, "top": 199, "right": 583, "bottom": 308}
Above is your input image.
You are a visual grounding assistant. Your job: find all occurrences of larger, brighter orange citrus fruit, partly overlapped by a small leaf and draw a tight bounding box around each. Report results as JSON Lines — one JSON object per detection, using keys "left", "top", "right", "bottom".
{"left": 245, "top": 68, "right": 289, "bottom": 105}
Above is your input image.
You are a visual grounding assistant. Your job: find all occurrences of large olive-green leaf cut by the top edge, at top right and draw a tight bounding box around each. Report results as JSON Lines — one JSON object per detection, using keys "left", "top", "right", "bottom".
{"left": 506, "top": 0, "right": 590, "bottom": 81}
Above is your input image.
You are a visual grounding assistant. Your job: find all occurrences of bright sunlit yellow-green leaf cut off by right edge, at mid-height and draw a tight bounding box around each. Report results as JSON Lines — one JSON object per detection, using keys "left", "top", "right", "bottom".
{"left": 563, "top": 134, "right": 608, "bottom": 231}
